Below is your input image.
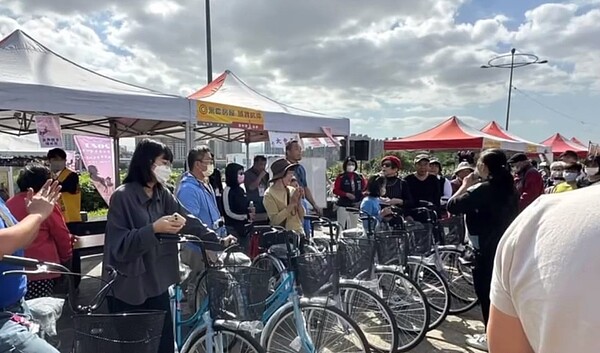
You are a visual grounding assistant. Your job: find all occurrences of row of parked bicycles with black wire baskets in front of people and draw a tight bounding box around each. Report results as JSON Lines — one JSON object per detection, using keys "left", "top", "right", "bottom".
{"left": 1, "top": 202, "right": 476, "bottom": 353}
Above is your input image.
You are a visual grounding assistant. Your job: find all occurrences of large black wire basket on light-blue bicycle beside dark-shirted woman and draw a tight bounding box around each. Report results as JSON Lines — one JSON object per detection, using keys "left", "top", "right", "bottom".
{"left": 206, "top": 266, "right": 271, "bottom": 321}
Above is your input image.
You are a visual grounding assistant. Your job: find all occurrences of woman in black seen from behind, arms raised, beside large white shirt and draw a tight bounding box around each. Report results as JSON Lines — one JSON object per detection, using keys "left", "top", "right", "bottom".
{"left": 448, "top": 149, "right": 519, "bottom": 351}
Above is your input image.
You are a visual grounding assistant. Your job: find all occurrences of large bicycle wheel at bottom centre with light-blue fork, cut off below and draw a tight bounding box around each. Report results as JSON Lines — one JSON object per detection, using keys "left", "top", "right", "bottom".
{"left": 263, "top": 303, "right": 370, "bottom": 353}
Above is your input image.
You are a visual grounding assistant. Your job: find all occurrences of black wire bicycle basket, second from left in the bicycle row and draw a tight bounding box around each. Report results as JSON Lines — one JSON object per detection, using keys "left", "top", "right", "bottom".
{"left": 292, "top": 253, "right": 336, "bottom": 297}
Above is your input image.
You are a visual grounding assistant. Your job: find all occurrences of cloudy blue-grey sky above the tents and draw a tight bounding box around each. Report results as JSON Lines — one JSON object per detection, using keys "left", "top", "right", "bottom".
{"left": 0, "top": 0, "right": 600, "bottom": 142}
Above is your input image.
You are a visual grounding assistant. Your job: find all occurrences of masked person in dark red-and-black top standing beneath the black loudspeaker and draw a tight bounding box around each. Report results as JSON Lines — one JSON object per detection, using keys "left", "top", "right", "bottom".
{"left": 333, "top": 157, "right": 367, "bottom": 229}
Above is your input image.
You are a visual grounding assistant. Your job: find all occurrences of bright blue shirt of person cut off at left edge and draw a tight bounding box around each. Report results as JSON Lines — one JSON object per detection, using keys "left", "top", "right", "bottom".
{"left": 0, "top": 199, "right": 27, "bottom": 308}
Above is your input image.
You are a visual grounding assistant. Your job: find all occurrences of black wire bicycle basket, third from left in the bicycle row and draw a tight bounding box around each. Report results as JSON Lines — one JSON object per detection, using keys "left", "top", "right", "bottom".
{"left": 338, "top": 238, "right": 375, "bottom": 278}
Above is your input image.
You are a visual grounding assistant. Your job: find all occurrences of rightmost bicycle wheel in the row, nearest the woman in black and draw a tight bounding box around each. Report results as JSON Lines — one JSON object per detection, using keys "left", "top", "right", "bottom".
{"left": 439, "top": 249, "right": 479, "bottom": 315}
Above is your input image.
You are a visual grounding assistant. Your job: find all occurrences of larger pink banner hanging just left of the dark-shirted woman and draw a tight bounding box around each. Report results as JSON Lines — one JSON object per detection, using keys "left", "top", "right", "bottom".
{"left": 73, "top": 135, "right": 115, "bottom": 205}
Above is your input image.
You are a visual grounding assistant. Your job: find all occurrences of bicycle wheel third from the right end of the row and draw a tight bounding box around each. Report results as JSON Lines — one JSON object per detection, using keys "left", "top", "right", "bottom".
{"left": 375, "top": 268, "right": 430, "bottom": 352}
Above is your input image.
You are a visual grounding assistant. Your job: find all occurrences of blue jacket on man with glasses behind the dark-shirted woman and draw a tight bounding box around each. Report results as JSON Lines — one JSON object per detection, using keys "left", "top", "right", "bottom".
{"left": 177, "top": 172, "right": 221, "bottom": 230}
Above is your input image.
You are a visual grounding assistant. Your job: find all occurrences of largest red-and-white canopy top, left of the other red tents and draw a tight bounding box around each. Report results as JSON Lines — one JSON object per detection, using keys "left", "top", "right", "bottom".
{"left": 383, "top": 116, "right": 526, "bottom": 152}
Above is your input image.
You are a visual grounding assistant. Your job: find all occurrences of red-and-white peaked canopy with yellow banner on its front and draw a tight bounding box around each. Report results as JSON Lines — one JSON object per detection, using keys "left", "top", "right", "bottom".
{"left": 188, "top": 70, "right": 350, "bottom": 143}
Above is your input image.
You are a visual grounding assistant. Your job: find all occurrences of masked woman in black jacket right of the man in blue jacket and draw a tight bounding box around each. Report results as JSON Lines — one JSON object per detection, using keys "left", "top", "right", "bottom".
{"left": 223, "top": 163, "right": 254, "bottom": 251}
